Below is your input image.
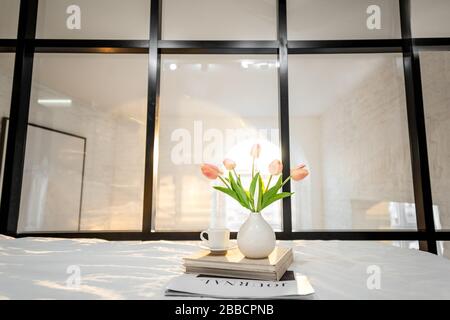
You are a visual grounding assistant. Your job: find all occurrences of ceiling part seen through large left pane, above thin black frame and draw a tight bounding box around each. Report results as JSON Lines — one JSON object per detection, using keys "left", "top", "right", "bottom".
{"left": 32, "top": 54, "right": 148, "bottom": 118}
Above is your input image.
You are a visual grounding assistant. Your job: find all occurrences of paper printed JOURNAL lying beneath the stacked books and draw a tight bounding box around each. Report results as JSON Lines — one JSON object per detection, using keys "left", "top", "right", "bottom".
{"left": 164, "top": 271, "right": 314, "bottom": 299}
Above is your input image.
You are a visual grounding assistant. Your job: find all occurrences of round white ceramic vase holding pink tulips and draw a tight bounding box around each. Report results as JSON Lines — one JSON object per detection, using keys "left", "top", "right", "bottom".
{"left": 237, "top": 212, "right": 276, "bottom": 259}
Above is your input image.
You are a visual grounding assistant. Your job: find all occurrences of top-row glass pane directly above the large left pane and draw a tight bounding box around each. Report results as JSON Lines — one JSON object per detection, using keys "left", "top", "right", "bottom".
{"left": 36, "top": 0, "right": 150, "bottom": 40}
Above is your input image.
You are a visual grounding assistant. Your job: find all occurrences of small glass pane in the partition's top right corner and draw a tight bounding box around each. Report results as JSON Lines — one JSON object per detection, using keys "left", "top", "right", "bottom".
{"left": 411, "top": 0, "right": 450, "bottom": 38}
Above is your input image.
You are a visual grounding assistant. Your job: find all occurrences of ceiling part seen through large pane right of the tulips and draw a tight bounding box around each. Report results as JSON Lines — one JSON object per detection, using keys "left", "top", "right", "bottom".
{"left": 289, "top": 54, "right": 403, "bottom": 116}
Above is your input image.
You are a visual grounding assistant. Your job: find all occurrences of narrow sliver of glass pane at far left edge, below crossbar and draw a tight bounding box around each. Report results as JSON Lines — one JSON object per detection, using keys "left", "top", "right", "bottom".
{"left": 0, "top": 53, "right": 14, "bottom": 200}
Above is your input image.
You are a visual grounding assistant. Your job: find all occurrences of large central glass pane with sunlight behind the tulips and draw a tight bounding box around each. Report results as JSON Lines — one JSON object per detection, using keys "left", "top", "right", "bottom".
{"left": 154, "top": 55, "right": 281, "bottom": 231}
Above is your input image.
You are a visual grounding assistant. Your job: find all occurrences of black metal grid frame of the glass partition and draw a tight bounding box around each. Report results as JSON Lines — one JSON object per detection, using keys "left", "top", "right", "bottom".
{"left": 0, "top": 0, "right": 450, "bottom": 253}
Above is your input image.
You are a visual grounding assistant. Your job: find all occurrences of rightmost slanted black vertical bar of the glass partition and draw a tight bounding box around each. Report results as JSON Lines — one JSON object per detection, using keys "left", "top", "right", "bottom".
{"left": 399, "top": 0, "right": 437, "bottom": 254}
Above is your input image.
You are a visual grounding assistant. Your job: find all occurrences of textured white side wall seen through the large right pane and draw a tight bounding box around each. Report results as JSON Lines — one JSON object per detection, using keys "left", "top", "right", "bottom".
{"left": 322, "top": 56, "right": 414, "bottom": 229}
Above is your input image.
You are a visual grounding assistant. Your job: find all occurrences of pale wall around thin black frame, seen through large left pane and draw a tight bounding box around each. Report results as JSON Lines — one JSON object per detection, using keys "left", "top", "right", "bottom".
{"left": 23, "top": 88, "right": 145, "bottom": 230}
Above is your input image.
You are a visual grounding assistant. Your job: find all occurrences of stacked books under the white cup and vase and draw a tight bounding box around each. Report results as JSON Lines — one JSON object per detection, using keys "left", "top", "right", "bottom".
{"left": 184, "top": 247, "right": 294, "bottom": 281}
